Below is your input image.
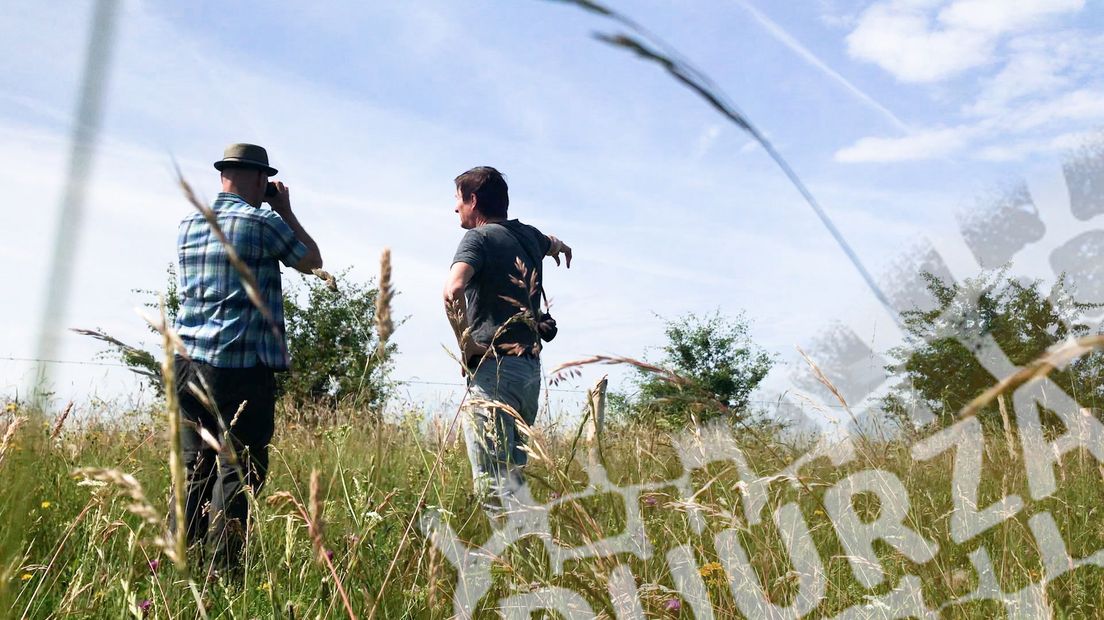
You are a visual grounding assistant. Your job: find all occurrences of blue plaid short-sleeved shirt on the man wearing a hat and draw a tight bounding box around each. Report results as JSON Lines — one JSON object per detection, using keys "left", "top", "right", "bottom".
{"left": 176, "top": 192, "right": 307, "bottom": 371}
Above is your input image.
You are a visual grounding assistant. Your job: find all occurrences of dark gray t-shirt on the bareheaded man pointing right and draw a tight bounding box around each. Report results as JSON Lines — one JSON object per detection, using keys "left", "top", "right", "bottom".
{"left": 453, "top": 220, "right": 552, "bottom": 352}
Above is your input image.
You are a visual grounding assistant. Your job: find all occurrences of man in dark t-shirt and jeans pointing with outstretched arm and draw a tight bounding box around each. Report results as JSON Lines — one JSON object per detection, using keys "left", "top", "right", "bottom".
{"left": 445, "top": 167, "right": 572, "bottom": 501}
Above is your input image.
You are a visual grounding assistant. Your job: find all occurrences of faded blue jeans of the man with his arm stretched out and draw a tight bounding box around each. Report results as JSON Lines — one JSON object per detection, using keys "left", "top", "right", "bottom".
{"left": 464, "top": 355, "right": 541, "bottom": 495}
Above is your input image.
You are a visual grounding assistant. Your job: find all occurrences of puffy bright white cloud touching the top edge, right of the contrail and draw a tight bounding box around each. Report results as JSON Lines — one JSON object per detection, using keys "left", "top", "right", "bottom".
{"left": 847, "top": 0, "right": 1084, "bottom": 83}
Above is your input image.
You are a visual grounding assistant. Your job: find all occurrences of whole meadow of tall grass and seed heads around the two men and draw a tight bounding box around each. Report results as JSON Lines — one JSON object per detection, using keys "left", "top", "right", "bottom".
{"left": 8, "top": 170, "right": 1104, "bottom": 619}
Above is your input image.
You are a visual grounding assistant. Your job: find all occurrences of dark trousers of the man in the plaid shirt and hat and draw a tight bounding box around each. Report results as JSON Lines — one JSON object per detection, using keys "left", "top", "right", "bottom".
{"left": 170, "top": 356, "right": 276, "bottom": 571}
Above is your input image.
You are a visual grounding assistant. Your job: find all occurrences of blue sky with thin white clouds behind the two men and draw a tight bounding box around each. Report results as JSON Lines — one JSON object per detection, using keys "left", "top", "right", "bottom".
{"left": 0, "top": 0, "right": 1104, "bottom": 423}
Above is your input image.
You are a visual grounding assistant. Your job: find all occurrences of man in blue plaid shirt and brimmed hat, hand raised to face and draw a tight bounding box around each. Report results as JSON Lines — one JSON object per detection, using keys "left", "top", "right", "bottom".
{"left": 173, "top": 145, "right": 322, "bottom": 571}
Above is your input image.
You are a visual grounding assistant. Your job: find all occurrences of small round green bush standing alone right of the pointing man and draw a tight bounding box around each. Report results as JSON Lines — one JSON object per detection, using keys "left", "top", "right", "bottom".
{"left": 618, "top": 311, "right": 773, "bottom": 428}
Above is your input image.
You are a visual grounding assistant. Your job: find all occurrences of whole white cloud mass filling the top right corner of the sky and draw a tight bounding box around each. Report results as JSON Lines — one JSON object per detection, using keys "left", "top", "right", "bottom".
{"left": 836, "top": 0, "right": 1104, "bottom": 162}
